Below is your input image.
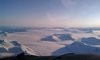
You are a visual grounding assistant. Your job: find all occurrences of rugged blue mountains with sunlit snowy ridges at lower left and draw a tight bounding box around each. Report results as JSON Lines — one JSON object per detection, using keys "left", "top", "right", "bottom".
{"left": 0, "top": 32, "right": 36, "bottom": 57}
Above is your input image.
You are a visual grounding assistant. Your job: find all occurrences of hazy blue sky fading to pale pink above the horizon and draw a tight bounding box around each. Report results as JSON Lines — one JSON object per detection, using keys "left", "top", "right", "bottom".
{"left": 0, "top": 0, "right": 100, "bottom": 27}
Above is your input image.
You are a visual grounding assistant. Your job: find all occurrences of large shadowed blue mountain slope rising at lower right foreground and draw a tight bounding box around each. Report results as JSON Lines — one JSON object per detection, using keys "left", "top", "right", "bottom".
{"left": 52, "top": 41, "right": 100, "bottom": 55}
